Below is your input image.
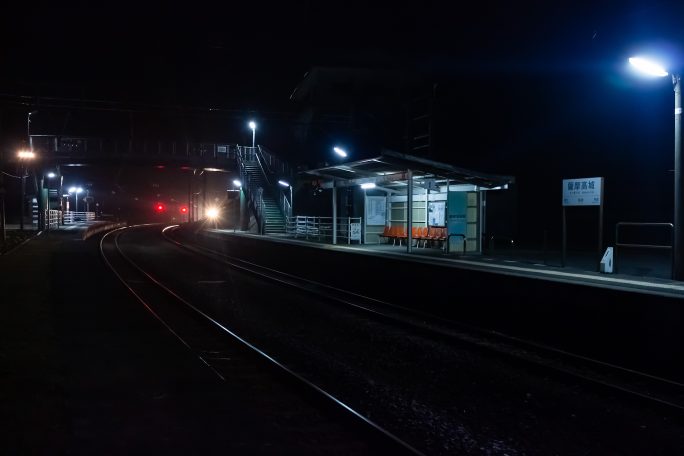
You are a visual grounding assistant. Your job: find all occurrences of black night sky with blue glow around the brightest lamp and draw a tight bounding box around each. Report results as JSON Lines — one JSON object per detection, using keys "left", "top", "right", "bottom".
{"left": 0, "top": 1, "right": 684, "bottom": 246}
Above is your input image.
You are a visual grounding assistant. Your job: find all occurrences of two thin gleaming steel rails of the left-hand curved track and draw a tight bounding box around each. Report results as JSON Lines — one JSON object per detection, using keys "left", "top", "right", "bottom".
{"left": 100, "top": 225, "right": 424, "bottom": 456}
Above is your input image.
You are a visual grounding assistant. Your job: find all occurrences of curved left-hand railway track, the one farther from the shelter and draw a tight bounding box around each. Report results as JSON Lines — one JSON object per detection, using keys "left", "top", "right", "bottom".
{"left": 100, "top": 226, "right": 423, "bottom": 455}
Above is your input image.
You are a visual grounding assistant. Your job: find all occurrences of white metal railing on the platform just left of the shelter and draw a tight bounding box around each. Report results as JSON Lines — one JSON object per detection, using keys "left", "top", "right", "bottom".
{"left": 285, "top": 215, "right": 363, "bottom": 244}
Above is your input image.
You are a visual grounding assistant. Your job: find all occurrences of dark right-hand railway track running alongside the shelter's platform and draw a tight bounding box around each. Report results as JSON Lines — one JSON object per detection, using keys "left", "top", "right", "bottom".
{"left": 163, "top": 226, "right": 684, "bottom": 417}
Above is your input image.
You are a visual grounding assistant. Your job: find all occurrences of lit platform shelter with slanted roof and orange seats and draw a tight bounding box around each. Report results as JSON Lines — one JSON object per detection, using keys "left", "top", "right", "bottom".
{"left": 302, "top": 150, "right": 515, "bottom": 253}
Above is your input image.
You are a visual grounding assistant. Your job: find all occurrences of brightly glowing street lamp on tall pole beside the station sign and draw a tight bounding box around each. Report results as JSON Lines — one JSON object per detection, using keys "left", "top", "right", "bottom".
{"left": 629, "top": 57, "right": 684, "bottom": 280}
